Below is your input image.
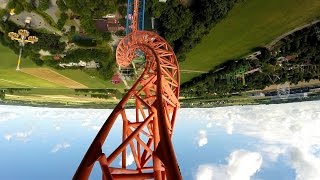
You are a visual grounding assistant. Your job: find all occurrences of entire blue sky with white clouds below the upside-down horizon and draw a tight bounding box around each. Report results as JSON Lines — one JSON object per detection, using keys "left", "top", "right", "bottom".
{"left": 0, "top": 101, "right": 320, "bottom": 180}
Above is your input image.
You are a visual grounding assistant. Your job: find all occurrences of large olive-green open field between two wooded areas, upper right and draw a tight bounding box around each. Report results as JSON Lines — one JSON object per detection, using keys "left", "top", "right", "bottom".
{"left": 180, "top": 0, "right": 320, "bottom": 82}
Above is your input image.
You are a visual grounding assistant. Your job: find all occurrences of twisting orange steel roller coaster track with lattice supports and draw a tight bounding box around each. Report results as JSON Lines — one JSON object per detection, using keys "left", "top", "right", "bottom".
{"left": 73, "top": 0, "right": 182, "bottom": 180}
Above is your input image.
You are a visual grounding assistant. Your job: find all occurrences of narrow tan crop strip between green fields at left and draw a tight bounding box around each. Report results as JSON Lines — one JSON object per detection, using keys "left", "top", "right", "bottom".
{"left": 21, "top": 68, "right": 87, "bottom": 88}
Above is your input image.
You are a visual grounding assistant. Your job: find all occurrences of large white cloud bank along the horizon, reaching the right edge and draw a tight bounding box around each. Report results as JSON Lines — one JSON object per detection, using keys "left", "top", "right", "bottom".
{"left": 179, "top": 101, "right": 320, "bottom": 180}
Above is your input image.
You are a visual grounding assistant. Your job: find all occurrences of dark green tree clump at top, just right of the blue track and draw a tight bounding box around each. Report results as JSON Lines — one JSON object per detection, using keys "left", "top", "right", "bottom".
{"left": 146, "top": 0, "right": 243, "bottom": 61}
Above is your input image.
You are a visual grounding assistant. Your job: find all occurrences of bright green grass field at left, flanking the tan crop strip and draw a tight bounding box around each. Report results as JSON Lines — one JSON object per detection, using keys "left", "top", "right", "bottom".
{"left": 0, "top": 44, "right": 124, "bottom": 89}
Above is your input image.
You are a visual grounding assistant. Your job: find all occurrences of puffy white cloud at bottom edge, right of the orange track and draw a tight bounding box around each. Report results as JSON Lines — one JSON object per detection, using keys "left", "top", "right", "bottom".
{"left": 196, "top": 150, "right": 262, "bottom": 180}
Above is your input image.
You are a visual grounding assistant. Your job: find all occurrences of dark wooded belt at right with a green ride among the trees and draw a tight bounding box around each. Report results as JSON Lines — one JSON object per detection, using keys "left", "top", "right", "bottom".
{"left": 181, "top": 23, "right": 320, "bottom": 96}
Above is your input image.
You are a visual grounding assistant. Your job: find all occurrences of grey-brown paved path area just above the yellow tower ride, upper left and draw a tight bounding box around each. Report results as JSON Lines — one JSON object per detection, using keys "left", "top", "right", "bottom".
{"left": 10, "top": 11, "right": 62, "bottom": 35}
